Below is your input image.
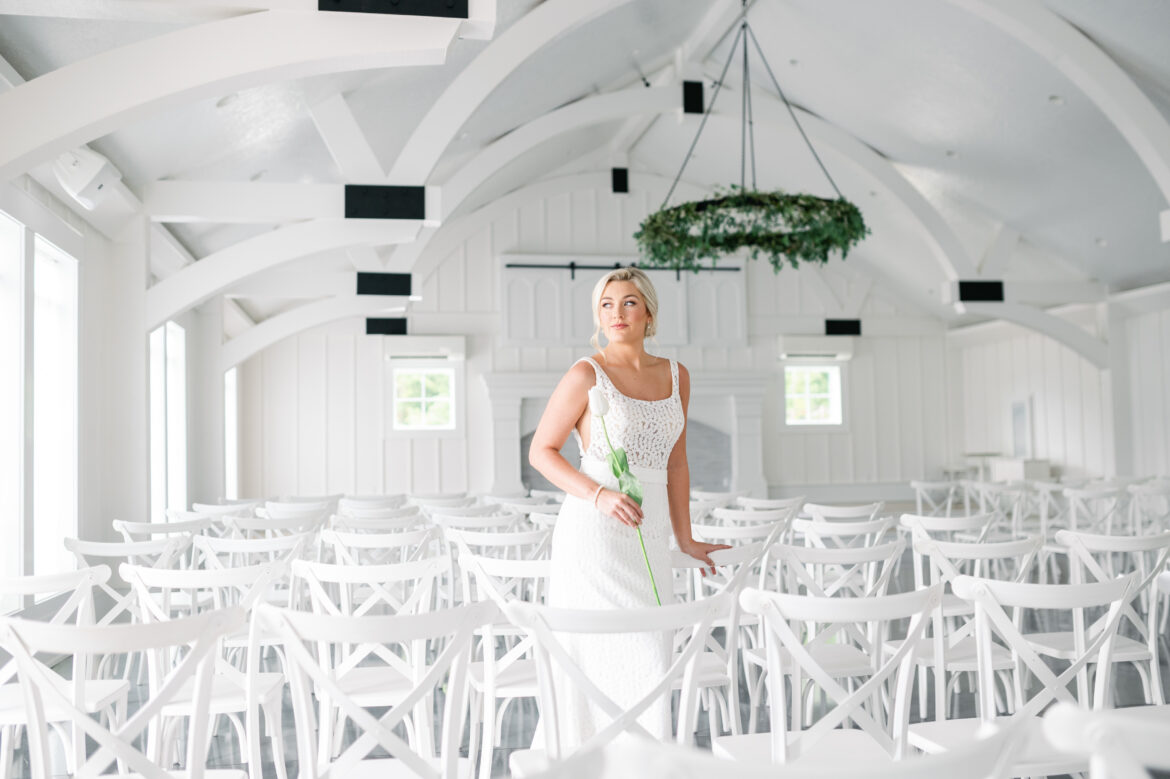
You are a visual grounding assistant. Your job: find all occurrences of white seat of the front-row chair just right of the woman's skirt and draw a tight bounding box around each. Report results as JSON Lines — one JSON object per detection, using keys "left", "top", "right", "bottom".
{"left": 711, "top": 728, "right": 894, "bottom": 777}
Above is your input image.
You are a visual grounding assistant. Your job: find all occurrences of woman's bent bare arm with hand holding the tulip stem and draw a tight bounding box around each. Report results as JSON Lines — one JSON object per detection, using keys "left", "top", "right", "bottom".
{"left": 528, "top": 363, "right": 642, "bottom": 528}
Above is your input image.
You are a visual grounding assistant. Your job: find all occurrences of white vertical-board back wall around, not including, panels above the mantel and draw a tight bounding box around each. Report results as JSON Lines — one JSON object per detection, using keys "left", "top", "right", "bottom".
{"left": 240, "top": 174, "right": 952, "bottom": 496}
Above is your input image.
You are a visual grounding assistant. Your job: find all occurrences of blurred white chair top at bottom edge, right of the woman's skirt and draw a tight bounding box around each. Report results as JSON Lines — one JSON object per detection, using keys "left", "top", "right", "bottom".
{"left": 541, "top": 728, "right": 1014, "bottom": 779}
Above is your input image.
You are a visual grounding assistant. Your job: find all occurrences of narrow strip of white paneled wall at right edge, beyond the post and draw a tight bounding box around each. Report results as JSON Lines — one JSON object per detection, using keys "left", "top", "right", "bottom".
{"left": 1126, "top": 310, "right": 1170, "bottom": 476}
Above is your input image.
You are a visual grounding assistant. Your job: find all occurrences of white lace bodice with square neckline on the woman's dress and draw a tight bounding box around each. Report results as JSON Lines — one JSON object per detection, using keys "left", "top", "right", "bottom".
{"left": 573, "top": 357, "right": 686, "bottom": 470}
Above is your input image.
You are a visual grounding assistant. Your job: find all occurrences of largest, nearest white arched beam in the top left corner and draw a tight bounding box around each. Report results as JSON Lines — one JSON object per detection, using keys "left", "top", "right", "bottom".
{"left": 0, "top": 11, "right": 460, "bottom": 181}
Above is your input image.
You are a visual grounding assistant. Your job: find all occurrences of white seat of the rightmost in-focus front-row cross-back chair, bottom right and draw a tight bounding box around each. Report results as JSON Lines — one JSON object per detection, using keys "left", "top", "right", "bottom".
{"left": 907, "top": 717, "right": 1088, "bottom": 777}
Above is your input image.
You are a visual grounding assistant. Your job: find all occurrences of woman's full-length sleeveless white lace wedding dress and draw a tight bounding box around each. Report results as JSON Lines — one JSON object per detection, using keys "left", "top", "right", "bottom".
{"left": 549, "top": 358, "right": 684, "bottom": 754}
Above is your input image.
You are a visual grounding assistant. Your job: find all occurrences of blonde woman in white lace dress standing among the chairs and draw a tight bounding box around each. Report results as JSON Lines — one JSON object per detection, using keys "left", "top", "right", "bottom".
{"left": 529, "top": 268, "right": 727, "bottom": 754}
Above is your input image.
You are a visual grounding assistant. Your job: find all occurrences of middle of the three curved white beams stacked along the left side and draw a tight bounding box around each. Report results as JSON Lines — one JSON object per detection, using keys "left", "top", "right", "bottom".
{"left": 146, "top": 219, "right": 421, "bottom": 331}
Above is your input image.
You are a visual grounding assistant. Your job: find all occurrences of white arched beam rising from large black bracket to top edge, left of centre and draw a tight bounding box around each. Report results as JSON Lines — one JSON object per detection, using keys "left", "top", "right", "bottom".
{"left": 390, "top": 0, "right": 631, "bottom": 185}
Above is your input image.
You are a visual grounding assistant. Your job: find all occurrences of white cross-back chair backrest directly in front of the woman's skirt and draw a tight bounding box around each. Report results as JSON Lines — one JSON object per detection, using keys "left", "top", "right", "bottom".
{"left": 503, "top": 594, "right": 730, "bottom": 759}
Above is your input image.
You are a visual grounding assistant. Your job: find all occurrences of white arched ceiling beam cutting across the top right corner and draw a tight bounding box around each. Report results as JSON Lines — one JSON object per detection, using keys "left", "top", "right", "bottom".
{"left": 950, "top": 0, "right": 1170, "bottom": 241}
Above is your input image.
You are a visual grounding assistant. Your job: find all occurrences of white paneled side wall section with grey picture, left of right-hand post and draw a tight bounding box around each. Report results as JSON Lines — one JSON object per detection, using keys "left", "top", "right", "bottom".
{"left": 950, "top": 325, "right": 1114, "bottom": 476}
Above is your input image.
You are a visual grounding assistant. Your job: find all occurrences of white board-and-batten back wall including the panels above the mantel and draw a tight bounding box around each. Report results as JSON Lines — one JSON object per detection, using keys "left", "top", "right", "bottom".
{"left": 240, "top": 178, "right": 957, "bottom": 496}
